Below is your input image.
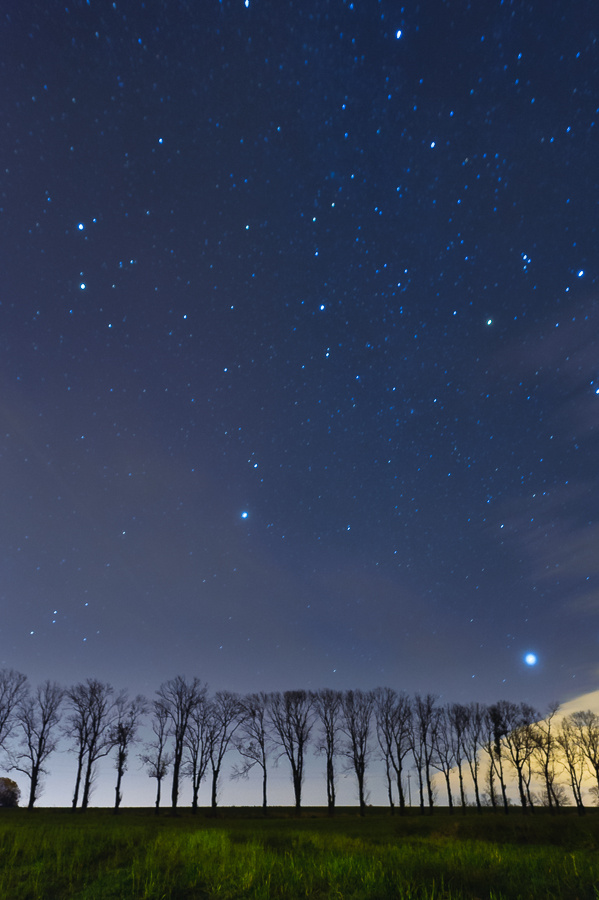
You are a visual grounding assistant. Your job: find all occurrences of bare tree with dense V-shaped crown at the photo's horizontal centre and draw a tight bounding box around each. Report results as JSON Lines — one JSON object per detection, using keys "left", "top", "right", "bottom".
{"left": 268, "top": 691, "right": 314, "bottom": 815}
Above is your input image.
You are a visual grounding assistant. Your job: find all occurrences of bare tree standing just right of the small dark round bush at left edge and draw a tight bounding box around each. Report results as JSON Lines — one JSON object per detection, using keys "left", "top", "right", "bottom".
{"left": 10, "top": 681, "right": 64, "bottom": 809}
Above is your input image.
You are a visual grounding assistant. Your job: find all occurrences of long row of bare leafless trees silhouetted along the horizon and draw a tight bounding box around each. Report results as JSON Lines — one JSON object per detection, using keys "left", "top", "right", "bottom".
{"left": 0, "top": 669, "right": 599, "bottom": 815}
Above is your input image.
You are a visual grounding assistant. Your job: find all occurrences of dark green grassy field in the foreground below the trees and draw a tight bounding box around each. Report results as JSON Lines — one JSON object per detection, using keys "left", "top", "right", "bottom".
{"left": 0, "top": 809, "right": 599, "bottom": 900}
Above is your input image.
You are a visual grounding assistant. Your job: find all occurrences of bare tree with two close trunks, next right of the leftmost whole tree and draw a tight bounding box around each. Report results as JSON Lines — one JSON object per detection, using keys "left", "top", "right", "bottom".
{"left": 65, "top": 678, "right": 117, "bottom": 810}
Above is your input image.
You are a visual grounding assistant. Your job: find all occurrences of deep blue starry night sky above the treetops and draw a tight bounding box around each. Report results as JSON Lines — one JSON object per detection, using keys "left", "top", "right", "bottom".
{"left": 0, "top": 0, "right": 599, "bottom": 716}
